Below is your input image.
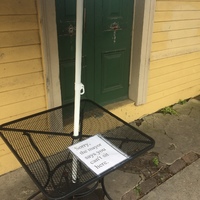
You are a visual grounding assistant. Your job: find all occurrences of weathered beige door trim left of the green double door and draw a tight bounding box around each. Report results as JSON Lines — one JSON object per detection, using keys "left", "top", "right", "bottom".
{"left": 37, "top": 0, "right": 62, "bottom": 108}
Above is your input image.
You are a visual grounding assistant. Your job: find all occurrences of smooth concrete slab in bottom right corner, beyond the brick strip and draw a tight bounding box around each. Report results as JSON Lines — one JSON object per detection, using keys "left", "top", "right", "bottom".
{"left": 142, "top": 159, "right": 200, "bottom": 200}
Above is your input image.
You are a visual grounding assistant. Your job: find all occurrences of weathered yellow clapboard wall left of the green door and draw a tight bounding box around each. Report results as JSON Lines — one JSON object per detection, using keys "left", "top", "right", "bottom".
{"left": 0, "top": 0, "right": 46, "bottom": 174}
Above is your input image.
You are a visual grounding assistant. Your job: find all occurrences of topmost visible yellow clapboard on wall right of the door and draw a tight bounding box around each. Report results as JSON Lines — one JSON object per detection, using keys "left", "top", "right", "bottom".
{"left": 156, "top": 0, "right": 200, "bottom": 11}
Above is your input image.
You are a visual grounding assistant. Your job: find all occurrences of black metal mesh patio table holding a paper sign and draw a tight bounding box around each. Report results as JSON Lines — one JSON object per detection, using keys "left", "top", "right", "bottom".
{"left": 0, "top": 100, "right": 154, "bottom": 200}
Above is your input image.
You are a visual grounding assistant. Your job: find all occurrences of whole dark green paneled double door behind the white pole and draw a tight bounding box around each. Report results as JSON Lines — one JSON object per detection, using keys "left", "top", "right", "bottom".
{"left": 56, "top": 0, "right": 133, "bottom": 103}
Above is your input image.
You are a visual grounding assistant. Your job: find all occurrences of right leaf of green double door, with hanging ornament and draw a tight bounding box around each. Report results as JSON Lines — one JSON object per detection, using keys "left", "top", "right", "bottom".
{"left": 95, "top": 0, "right": 133, "bottom": 103}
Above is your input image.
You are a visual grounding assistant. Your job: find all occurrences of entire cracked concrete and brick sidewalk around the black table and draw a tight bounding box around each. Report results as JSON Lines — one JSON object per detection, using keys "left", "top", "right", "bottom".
{"left": 0, "top": 98, "right": 200, "bottom": 200}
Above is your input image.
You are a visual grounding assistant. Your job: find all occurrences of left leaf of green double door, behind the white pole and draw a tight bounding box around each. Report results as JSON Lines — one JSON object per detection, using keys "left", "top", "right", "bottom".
{"left": 56, "top": 0, "right": 94, "bottom": 104}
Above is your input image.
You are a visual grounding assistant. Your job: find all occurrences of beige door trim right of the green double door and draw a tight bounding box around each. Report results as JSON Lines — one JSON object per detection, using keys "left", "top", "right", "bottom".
{"left": 129, "top": 0, "right": 156, "bottom": 105}
